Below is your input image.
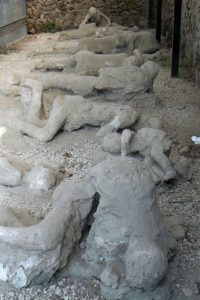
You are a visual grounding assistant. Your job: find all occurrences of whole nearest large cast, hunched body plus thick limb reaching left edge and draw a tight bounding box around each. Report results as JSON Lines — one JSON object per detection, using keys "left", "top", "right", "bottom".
{"left": 0, "top": 157, "right": 174, "bottom": 299}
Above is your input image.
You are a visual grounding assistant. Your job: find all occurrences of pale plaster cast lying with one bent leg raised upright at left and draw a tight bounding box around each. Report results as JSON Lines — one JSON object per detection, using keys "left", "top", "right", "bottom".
{"left": 0, "top": 79, "right": 138, "bottom": 142}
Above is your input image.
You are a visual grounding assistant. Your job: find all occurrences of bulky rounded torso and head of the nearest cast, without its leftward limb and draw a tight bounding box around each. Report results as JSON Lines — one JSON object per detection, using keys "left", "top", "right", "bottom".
{"left": 66, "top": 157, "right": 176, "bottom": 300}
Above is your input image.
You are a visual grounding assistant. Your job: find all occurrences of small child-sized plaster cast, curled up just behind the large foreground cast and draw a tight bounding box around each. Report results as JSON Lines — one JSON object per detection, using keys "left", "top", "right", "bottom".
{"left": 103, "top": 128, "right": 176, "bottom": 183}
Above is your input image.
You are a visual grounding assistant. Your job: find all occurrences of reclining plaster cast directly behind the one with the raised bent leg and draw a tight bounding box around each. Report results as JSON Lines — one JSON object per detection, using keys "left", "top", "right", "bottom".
{"left": 3, "top": 59, "right": 159, "bottom": 98}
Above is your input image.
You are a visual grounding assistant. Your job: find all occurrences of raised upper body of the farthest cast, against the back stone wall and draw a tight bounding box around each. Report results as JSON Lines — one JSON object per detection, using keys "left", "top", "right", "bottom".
{"left": 79, "top": 7, "right": 111, "bottom": 28}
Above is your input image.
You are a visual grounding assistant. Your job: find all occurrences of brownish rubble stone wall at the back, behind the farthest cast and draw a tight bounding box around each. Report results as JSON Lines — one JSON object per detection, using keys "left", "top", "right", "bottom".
{"left": 27, "top": 0, "right": 148, "bottom": 33}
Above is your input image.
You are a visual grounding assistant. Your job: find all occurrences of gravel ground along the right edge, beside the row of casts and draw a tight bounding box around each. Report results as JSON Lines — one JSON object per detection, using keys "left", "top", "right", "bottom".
{"left": 155, "top": 68, "right": 200, "bottom": 300}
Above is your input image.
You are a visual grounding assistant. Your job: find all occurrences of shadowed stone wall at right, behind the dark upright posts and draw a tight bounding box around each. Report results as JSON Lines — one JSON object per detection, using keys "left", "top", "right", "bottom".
{"left": 163, "top": 0, "right": 200, "bottom": 84}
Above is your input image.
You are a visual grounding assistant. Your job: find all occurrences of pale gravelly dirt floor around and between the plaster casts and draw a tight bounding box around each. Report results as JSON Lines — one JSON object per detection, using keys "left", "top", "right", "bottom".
{"left": 0, "top": 34, "right": 200, "bottom": 300}
